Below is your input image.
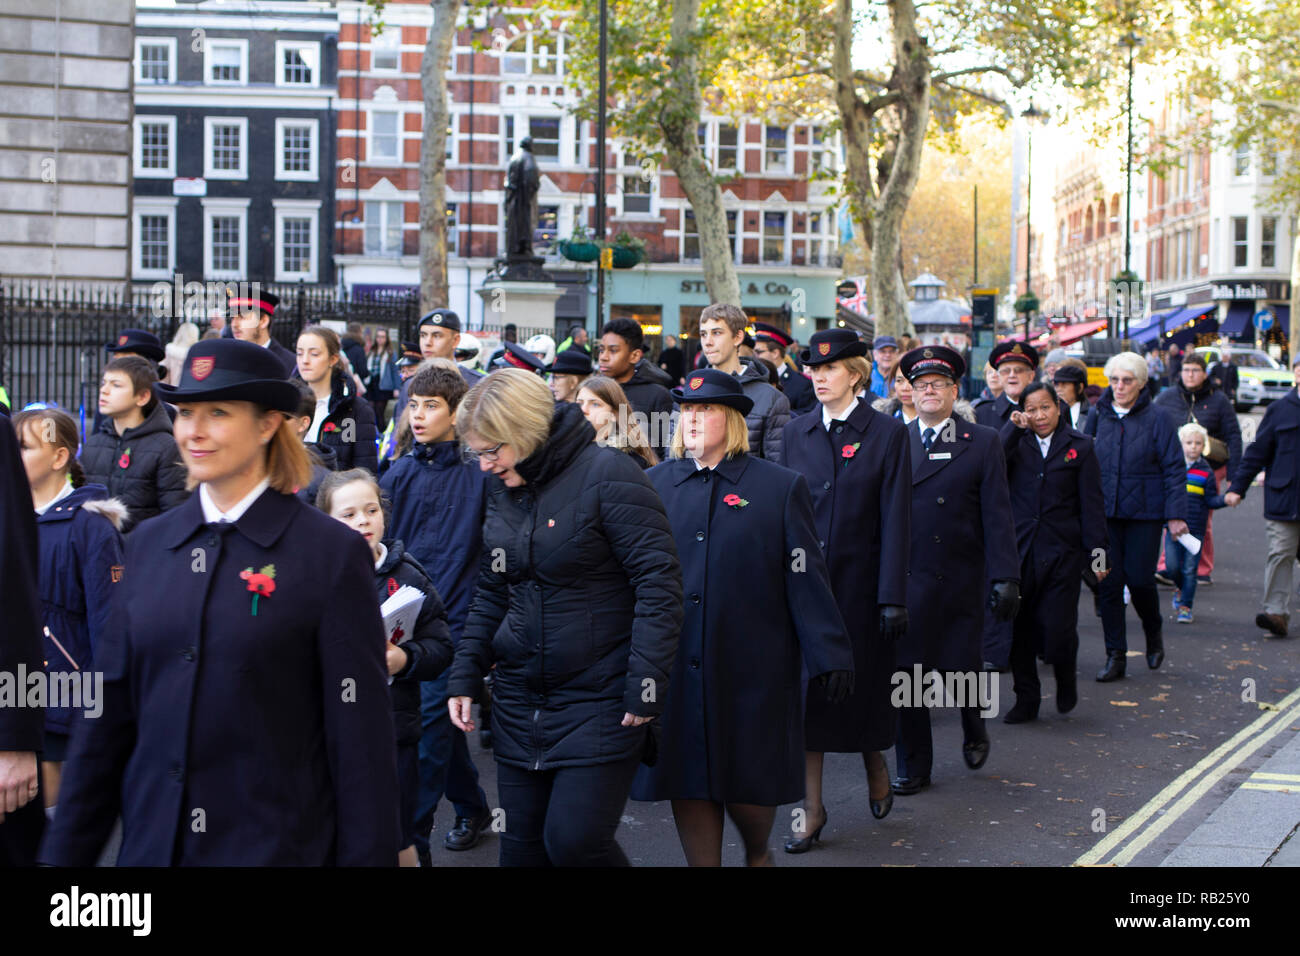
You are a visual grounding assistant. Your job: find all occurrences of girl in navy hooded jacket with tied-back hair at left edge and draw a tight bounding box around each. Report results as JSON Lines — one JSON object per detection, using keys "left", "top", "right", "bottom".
{"left": 13, "top": 408, "right": 126, "bottom": 809}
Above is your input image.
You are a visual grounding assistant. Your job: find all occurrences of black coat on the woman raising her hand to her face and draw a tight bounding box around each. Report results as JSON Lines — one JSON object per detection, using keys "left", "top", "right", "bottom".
{"left": 1001, "top": 418, "right": 1109, "bottom": 662}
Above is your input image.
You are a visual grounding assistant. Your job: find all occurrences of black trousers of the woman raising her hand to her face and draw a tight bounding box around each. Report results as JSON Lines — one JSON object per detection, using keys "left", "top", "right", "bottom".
{"left": 1011, "top": 554, "right": 1083, "bottom": 710}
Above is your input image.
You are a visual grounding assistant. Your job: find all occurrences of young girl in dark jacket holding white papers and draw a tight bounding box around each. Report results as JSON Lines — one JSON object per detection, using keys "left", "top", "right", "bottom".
{"left": 316, "top": 468, "right": 452, "bottom": 866}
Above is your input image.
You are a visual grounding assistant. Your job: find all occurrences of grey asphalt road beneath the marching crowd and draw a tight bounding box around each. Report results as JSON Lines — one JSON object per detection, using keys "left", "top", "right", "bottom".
{"left": 434, "top": 415, "right": 1300, "bottom": 866}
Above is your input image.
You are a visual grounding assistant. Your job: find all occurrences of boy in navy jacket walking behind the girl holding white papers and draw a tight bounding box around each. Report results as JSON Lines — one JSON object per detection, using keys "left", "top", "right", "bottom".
{"left": 380, "top": 359, "right": 490, "bottom": 866}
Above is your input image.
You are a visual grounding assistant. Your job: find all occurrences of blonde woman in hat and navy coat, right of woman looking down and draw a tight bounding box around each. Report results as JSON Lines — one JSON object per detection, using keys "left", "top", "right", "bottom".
{"left": 632, "top": 369, "right": 857, "bottom": 866}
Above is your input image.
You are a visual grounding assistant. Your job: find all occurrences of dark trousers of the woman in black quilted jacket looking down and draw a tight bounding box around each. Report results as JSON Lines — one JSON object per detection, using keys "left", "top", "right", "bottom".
{"left": 497, "top": 749, "right": 641, "bottom": 866}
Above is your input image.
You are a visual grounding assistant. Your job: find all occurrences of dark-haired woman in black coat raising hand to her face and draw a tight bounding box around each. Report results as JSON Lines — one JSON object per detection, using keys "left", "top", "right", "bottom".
{"left": 1002, "top": 382, "right": 1108, "bottom": 723}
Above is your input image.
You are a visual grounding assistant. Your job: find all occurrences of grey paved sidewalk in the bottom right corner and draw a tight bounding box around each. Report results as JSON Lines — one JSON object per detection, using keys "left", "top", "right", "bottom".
{"left": 1160, "top": 726, "right": 1300, "bottom": 866}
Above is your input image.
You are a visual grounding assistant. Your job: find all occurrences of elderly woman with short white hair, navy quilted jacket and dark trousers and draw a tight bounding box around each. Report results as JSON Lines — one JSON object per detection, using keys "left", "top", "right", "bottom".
{"left": 1084, "top": 352, "right": 1187, "bottom": 682}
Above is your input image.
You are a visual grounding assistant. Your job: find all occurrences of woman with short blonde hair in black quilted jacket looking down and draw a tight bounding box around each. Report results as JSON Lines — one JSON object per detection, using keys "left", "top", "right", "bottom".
{"left": 447, "top": 368, "right": 683, "bottom": 866}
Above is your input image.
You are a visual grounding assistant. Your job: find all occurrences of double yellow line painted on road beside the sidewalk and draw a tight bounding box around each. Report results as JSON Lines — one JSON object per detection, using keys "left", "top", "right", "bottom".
{"left": 1074, "top": 688, "right": 1300, "bottom": 866}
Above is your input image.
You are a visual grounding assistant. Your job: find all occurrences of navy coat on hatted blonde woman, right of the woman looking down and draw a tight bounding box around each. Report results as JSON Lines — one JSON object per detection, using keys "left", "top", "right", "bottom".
{"left": 632, "top": 455, "right": 852, "bottom": 806}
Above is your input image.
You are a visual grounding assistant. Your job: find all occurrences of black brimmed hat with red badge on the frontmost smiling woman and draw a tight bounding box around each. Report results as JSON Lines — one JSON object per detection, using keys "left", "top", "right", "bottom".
{"left": 153, "top": 338, "right": 302, "bottom": 415}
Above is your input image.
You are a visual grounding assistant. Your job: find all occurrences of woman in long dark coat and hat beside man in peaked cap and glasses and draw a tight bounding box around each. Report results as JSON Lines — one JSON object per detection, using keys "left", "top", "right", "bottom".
{"left": 781, "top": 329, "right": 911, "bottom": 853}
